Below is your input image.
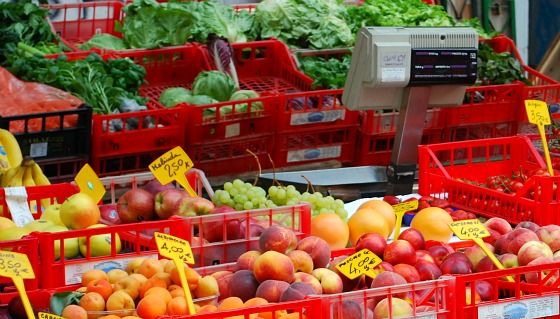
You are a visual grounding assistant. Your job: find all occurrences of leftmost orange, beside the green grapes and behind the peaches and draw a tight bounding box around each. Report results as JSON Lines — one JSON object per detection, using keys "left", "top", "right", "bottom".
{"left": 311, "top": 212, "right": 350, "bottom": 250}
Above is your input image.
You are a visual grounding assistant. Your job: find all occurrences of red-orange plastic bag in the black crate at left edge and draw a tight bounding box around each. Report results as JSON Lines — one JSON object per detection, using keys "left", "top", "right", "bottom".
{"left": 0, "top": 67, "right": 84, "bottom": 133}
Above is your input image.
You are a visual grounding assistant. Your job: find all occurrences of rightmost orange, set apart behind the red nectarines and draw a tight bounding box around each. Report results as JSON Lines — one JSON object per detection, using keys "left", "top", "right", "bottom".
{"left": 410, "top": 207, "right": 453, "bottom": 243}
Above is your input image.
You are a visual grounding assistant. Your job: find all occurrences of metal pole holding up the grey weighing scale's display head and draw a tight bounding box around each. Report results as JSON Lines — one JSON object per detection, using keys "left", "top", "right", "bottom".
{"left": 386, "top": 86, "right": 430, "bottom": 195}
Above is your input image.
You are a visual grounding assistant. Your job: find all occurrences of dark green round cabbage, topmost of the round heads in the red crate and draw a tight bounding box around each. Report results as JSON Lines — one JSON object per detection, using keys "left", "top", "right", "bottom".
{"left": 192, "top": 70, "right": 238, "bottom": 102}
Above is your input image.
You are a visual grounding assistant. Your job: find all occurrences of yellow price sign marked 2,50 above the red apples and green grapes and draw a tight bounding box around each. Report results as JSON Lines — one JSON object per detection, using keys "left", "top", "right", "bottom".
{"left": 150, "top": 146, "right": 197, "bottom": 197}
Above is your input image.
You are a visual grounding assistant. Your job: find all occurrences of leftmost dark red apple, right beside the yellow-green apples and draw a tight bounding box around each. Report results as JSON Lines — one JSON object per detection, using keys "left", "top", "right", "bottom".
{"left": 117, "top": 188, "right": 157, "bottom": 224}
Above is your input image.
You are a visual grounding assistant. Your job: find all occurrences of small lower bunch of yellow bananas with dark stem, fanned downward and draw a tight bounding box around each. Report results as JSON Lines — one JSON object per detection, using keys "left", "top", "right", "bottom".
{"left": 0, "top": 156, "right": 50, "bottom": 187}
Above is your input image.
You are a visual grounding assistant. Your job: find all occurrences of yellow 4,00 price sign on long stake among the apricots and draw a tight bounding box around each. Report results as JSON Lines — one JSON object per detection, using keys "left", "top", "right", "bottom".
{"left": 154, "top": 232, "right": 195, "bottom": 315}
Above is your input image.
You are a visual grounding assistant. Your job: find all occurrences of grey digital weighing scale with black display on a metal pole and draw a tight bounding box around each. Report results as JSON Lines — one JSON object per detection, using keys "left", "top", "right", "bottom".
{"left": 342, "top": 27, "right": 478, "bottom": 195}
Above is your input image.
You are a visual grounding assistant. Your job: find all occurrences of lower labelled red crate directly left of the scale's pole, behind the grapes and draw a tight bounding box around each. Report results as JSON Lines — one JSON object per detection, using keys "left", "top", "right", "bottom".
{"left": 273, "top": 125, "right": 358, "bottom": 167}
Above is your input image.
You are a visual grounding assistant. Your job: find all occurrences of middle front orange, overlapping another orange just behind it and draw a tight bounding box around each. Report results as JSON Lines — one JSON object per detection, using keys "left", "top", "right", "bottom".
{"left": 348, "top": 208, "right": 392, "bottom": 246}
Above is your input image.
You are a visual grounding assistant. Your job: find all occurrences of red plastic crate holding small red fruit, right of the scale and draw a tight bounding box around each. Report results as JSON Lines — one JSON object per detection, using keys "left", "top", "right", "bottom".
{"left": 418, "top": 135, "right": 560, "bottom": 225}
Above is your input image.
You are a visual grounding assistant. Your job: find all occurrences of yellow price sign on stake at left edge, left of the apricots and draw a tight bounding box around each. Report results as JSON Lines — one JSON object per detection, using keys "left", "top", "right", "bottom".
{"left": 0, "top": 251, "right": 35, "bottom": 319}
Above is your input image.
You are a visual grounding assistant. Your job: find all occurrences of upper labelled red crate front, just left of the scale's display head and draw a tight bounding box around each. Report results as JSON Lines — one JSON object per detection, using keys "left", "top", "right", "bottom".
{"left": 277, "top": 89, "right": 359, "bottom": 133}
